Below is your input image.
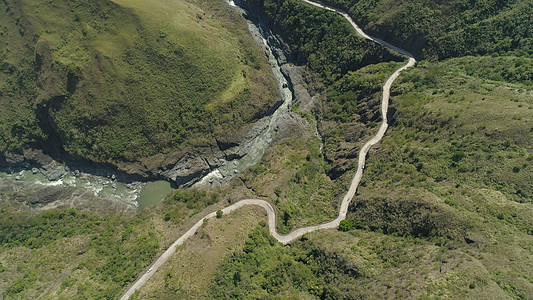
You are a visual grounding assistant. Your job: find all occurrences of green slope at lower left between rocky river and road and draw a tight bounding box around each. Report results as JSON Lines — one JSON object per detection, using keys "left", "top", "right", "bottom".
{"left": 0, "top": 190, "right": 224, "bottom": 299}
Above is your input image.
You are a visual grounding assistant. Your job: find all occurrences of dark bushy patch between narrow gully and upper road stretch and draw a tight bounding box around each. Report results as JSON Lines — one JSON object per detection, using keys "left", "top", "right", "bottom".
{"left": 319, "top": 62, "right": 401, "bottom": 179}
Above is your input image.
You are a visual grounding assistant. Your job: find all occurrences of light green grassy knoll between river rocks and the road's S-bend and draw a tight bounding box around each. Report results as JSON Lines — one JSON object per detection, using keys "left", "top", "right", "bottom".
{"left": 239, "top": 120, "right": 340, "bottom": 233}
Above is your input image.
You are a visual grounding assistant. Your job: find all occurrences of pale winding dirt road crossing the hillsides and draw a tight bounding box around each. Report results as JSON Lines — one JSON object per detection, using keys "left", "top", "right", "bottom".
{"left": 120, "top": 0, "right": 416, "bottom": 300}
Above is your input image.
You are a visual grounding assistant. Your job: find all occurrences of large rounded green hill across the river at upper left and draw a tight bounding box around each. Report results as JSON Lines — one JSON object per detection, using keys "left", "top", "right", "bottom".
{"left": 0, "top": 0, "right": 275, "bottom": 163}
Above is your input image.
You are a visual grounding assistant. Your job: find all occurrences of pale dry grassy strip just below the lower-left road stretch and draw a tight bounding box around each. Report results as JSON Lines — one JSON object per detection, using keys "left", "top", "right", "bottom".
{"left": 132, "top": 207, "right": 266, "bottom": 299}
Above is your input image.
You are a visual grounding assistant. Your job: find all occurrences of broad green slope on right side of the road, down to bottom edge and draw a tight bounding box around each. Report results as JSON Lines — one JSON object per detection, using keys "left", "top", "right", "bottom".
{"left": 210, "top": 57, "right": 533, "bottom": 299}
